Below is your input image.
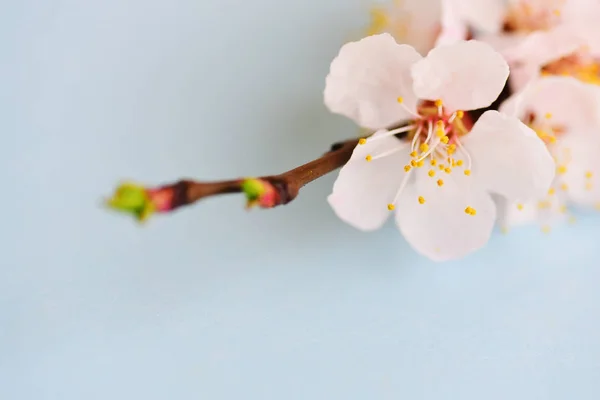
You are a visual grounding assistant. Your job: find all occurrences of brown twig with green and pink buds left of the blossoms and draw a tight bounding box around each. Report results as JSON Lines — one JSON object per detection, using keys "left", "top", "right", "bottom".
{"left": 107, "top": 139, "right": 359, "bottom": 221}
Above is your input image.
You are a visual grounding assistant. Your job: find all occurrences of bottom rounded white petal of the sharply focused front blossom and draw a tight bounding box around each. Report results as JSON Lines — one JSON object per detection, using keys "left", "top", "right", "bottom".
{"left": 396, "top": 169, "right": 496, "bottom": 261}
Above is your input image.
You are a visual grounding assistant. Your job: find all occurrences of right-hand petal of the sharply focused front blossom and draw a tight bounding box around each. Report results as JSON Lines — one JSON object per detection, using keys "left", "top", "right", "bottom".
{"left": 463, "top": 111, "right": 555, "bottom": 200}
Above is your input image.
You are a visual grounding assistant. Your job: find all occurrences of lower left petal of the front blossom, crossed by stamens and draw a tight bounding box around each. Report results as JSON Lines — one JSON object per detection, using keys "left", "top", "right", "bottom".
{"left": 327, "top": 131, "right": 410, "bottom": 231}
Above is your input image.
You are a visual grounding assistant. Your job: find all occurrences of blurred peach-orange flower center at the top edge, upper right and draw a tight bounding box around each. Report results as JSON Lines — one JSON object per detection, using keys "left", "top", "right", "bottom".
{"left": 504, "top": 0, "right": 564, "bottom": 33}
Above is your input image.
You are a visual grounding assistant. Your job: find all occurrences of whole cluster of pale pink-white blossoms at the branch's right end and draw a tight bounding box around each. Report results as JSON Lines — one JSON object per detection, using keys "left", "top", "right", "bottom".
{"left": 324, "top": 0, "right": 600, "bottom": 261}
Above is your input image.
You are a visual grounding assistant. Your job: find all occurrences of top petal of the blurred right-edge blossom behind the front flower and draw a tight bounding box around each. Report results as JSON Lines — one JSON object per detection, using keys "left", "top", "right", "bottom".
{"left": 500, "top": 76, "right": 600, "bottom": 131}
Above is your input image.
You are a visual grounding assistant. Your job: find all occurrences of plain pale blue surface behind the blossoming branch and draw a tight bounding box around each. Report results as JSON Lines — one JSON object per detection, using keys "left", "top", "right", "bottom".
{"left": 0, "top": 0, "right": 600, "bottom": 400}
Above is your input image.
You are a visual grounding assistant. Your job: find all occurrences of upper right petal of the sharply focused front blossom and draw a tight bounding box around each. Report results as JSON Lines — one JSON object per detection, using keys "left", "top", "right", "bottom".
{"left": 412, "top": 40, "right": 509, "bottom": 110}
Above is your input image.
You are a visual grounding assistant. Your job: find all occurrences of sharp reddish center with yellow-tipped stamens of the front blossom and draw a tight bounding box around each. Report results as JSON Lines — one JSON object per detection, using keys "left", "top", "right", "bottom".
{"left": 359, "top": 97, "right": 477, "bottom": 215}
